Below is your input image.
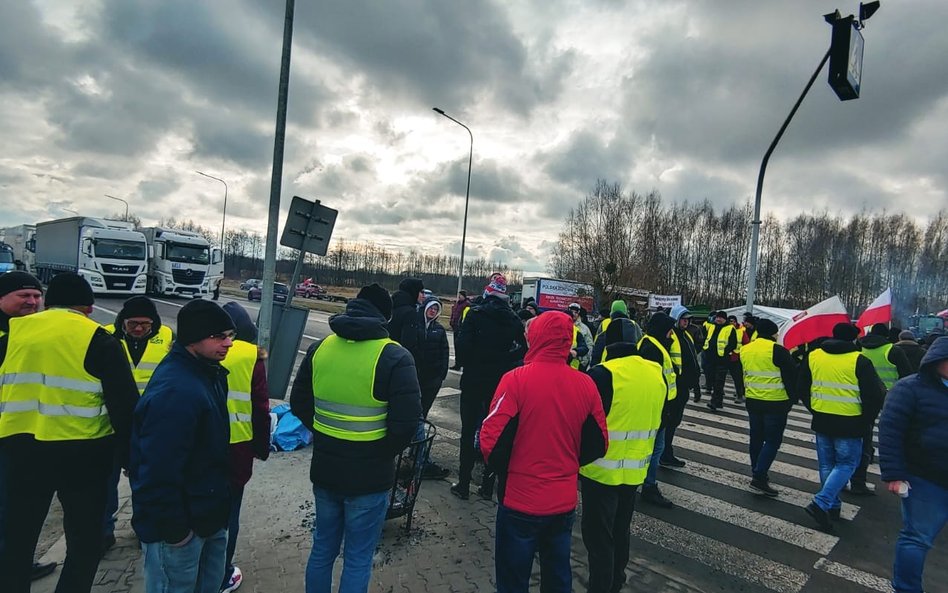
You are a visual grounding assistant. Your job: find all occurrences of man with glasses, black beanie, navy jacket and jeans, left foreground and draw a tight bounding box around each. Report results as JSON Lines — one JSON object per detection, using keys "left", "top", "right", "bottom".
{"left": 129, "top": 300, "right": 236, "bottom": 593}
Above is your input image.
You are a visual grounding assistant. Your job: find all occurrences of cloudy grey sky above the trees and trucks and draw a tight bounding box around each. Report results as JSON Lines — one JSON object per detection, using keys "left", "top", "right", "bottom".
{"left": 0, "top": 0, "right": 948, "bottom": 271}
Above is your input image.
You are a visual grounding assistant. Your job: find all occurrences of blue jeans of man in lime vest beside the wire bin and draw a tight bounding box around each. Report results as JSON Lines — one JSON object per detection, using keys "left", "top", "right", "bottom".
{"left": 306, "top": 487, "right": 389, "bottom": 593}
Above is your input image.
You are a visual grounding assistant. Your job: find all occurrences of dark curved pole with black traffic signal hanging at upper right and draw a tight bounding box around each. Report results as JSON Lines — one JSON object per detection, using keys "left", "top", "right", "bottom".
{"left": 745, "top": 2, "right": 879, "bottom": 313}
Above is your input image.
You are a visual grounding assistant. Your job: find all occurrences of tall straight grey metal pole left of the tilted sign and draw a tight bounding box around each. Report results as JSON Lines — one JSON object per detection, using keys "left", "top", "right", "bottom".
{"left": 257, "top": 0, "right": 296, "bottom": 350}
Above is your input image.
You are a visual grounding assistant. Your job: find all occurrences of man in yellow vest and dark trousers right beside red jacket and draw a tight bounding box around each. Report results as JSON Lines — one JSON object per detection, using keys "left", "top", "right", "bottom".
{"left": 579, "top": 328, "right": 668, "bottom": 593}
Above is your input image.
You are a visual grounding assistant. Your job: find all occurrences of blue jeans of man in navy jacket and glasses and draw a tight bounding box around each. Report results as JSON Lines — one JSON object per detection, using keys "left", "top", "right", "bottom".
{"left": 142, "top": 529, "right": 227, "bottom": 593}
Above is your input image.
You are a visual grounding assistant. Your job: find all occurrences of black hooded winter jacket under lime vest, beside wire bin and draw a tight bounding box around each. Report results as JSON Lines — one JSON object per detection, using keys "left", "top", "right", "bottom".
{"left": 290, "top": 299, "right": 421, "bottom": 496}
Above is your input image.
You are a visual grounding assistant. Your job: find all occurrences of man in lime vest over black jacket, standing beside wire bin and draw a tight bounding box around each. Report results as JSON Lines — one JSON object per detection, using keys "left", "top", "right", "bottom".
{"left": 290, "top": 284, "right": 421, "bottom": 591}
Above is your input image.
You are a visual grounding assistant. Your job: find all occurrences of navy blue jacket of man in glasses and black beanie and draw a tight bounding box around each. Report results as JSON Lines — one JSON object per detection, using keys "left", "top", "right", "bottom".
{"left": 128, "top": 342, "right": 230, "bottom": 543}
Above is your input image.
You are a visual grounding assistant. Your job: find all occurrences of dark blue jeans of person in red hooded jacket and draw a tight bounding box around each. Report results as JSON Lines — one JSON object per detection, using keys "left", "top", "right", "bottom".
{"left": 494, "top": 505, "right": 576, "bottom": 593}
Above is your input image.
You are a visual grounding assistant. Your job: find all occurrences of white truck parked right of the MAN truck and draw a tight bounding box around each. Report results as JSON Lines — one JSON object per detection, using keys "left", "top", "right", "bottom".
{"left": 142, "top": 227, "right": 223, "bottom": 297}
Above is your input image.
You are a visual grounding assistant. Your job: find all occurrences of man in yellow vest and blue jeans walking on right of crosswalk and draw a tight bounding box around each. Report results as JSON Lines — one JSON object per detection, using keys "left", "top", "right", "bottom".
{"left": 799, "top": 323, "right": 885, "bottom": 532}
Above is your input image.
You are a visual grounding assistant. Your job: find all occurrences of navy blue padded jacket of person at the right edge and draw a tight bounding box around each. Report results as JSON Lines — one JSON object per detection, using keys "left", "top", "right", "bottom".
{"left": 879, "top": 337, "right": 948, "bottom": 488}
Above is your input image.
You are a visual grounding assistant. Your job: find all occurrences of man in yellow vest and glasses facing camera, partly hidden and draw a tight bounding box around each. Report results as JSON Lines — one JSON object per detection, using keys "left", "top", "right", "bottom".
{"left": 102, "top": 296, "right": 174, "bottom": 554}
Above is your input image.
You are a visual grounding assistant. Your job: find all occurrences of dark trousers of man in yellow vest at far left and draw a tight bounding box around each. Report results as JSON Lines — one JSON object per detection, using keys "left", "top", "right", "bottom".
{"left": 0, "top": 437, "right": 114, "bottom": 593}
